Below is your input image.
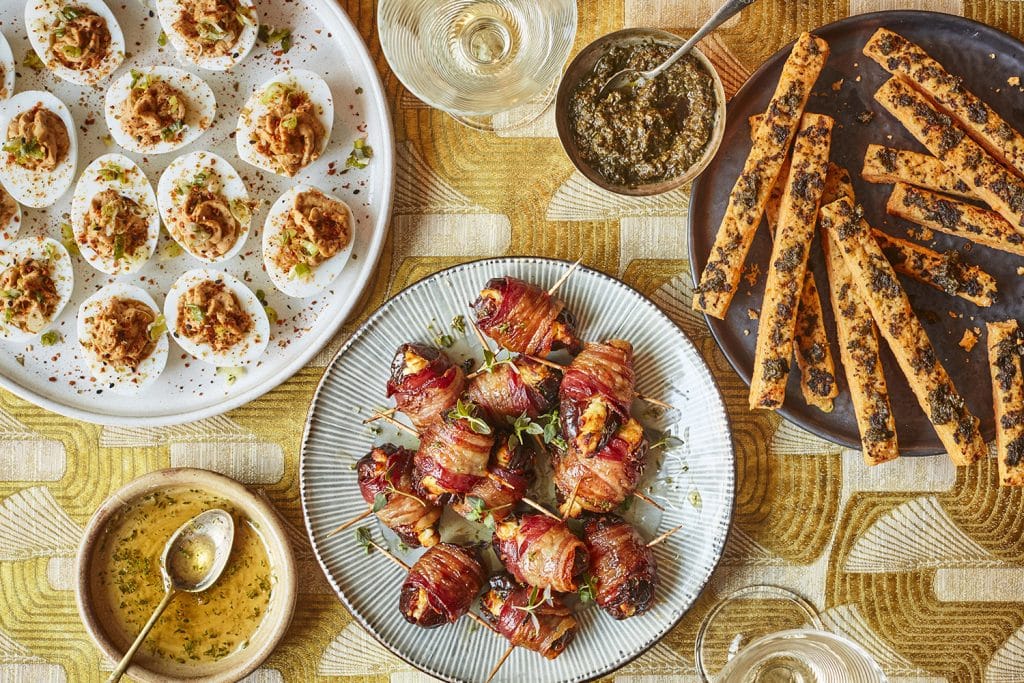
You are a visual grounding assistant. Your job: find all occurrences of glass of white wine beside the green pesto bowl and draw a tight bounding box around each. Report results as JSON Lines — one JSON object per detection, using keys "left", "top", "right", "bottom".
{"left": 377, "top": 0, "right": 577, "bottom": 131}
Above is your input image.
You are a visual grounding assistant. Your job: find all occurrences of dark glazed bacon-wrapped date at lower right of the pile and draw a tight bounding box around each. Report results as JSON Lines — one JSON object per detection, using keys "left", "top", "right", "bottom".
{"left": 584, "top": 515, "right": 657, "bottom": 618}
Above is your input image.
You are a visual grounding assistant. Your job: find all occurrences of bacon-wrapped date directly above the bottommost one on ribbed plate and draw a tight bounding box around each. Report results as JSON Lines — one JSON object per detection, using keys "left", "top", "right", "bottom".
{"left": 492, "top": 514, "right": 589, "bottom": 593}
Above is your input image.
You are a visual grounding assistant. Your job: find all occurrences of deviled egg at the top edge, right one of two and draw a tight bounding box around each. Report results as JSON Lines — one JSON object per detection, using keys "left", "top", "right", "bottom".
{"left": 157, "top": 0, "right": 259, "bottom": 71}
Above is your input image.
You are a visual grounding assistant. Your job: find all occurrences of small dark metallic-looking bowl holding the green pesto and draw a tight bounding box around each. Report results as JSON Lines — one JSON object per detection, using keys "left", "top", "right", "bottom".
{"left": 555, "top": 29, "right": 725, "bottom": 197}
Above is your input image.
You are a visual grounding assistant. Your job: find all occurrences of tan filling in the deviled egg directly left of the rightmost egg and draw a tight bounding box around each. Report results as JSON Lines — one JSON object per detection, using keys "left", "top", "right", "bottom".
{"left": 172, "top": 168, "right": 242, "bottom": 258}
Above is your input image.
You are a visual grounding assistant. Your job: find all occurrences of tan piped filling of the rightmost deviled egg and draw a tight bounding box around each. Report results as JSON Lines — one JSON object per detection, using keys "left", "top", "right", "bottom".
{"left": 273, "top": 189, "right": 352, "bottom": 278}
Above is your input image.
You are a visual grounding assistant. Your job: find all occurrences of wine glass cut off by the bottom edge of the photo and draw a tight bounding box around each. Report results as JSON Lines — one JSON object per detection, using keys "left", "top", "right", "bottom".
{"left": 694, "top": 586, "right": 887, "bottom": 683}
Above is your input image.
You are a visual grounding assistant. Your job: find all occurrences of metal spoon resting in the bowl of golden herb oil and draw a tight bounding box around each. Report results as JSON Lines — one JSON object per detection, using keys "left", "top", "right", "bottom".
{"left": 106, "top": 509, "right": 234, "bottom": 683}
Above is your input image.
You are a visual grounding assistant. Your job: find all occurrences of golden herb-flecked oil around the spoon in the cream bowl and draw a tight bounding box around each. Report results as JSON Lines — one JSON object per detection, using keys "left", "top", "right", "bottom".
{"left": 91, "top": 487, "right": 275, "bottom": 665}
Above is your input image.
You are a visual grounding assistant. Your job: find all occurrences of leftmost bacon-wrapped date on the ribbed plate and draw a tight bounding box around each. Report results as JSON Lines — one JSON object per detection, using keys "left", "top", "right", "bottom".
{"left": 355, "top": 443, "right": 441, "bottom": 548}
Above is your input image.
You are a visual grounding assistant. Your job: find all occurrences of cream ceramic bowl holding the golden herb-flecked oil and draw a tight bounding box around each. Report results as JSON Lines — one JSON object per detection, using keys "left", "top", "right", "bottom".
{"left": 75, "top": 468, "right": 296, "bottom": 683}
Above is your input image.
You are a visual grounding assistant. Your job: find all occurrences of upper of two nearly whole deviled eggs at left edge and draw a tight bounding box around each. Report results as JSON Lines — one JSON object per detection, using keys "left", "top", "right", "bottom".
{"left": 0, "top": 90, "right": 78, "bottom": 209}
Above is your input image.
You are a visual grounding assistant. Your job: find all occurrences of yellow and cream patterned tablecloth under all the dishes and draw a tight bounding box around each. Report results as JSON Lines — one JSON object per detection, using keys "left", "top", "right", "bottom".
{"left": 0, "top": 0, "right": 1024, "bottom": 683}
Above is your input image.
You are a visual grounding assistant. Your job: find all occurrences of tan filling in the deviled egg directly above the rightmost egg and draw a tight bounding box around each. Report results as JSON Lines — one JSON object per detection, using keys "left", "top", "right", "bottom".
{"left": 252, "top": 83, "right": 326, "bottom": 176}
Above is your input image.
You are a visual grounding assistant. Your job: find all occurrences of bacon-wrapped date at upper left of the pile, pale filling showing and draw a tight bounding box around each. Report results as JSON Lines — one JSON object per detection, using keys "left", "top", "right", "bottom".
{"left": 387, "top": 344, "right": 466, "bottom": 431}
